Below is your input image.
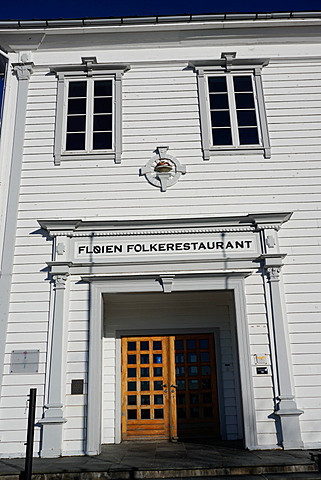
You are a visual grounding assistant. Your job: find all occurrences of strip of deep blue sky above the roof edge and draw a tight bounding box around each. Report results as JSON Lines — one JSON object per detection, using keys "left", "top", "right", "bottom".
{"left": 0, "top": 0, "right": 321, "bottom": 20}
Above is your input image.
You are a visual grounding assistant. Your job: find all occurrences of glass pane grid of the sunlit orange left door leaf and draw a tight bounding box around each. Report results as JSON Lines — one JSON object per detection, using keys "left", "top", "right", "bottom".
{"left": 126, "top": 339, "right": 164, "bottom": 421}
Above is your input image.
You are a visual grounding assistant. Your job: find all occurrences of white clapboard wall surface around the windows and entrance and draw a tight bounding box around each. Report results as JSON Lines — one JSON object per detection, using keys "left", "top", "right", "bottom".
{"left": 0, "top": 21, "right": 321, "bottom": 456}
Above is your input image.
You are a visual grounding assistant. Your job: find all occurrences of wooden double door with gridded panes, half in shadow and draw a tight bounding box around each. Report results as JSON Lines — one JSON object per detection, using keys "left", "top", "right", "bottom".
{"left": 122, "top": 334, "right": 219, "bottom": 440}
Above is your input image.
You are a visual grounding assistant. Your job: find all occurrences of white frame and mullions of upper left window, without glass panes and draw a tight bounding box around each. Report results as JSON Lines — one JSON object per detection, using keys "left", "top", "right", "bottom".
{"left": 50, "top": 57, "right": 130, "bottom": 165}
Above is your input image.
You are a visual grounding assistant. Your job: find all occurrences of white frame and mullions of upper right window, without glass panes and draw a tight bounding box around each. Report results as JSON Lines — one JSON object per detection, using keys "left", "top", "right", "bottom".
{"left": 189, "top": 53, "right": 271, "bottom": 160}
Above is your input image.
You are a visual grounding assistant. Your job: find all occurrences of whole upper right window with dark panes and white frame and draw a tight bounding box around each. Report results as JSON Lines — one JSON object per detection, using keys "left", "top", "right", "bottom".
{"left": 190, "top": 54, "right": 271, "bottom": 160}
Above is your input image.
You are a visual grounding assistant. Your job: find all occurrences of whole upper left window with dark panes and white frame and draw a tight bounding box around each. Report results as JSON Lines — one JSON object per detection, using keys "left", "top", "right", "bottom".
{"left": 51, "top": 58, "right": 129, "bottom": 165}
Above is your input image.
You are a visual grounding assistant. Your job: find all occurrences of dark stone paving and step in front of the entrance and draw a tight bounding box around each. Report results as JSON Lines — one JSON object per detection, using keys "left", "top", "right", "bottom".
{"left": 0, "top": 442, "right": 321, "bottom": 480}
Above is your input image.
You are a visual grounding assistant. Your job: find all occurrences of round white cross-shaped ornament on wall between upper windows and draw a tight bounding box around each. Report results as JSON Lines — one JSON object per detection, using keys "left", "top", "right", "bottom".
{"left": 140, "top": 146, "right": 186, "bottom": 192}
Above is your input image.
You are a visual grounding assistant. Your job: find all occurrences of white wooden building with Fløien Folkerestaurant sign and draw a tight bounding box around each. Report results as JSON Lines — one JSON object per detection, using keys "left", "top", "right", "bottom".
{"left": 0, "top": 12, "right": 321, "bottom": 458}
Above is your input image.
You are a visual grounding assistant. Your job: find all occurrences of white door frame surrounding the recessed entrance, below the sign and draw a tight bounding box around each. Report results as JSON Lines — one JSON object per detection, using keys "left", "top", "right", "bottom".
{"left": 82, "top": 270, "right": 258, "bottom": 455}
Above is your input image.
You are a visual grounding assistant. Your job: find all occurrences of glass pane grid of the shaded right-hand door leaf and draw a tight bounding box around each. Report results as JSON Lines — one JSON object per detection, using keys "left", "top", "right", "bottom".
{"left": 175, "top": 335, "right": 214, "bottom": 421}
